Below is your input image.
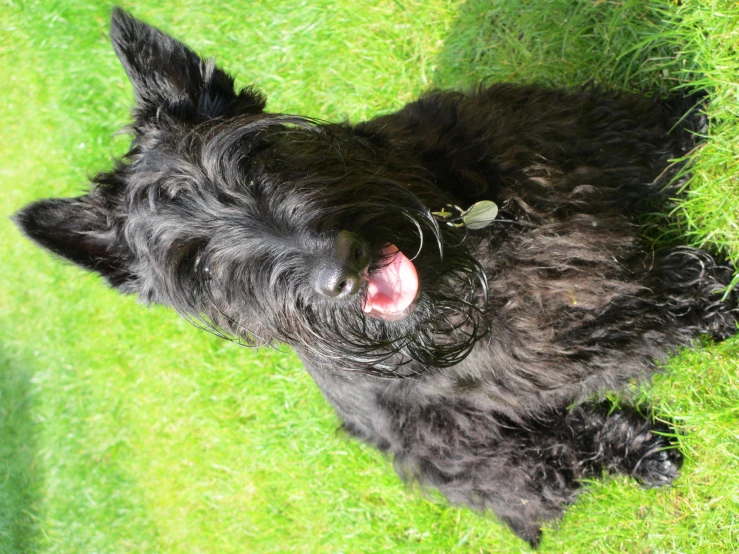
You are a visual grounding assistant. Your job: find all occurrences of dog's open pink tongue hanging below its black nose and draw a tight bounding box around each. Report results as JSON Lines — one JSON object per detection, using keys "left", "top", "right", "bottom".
{"left": 363, "top": 244, "right": 418, "bottom": 320}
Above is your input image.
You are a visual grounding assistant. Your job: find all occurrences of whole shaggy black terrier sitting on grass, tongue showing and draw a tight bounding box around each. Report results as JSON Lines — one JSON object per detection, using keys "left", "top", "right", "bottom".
{"left": 16, "top": 10, "right": 739, "bottom": 544}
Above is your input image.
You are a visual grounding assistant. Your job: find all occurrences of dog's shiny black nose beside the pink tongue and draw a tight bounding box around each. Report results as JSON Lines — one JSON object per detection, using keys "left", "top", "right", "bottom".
{"left": 314, "top": 231, "right": 370, "bottom": 298}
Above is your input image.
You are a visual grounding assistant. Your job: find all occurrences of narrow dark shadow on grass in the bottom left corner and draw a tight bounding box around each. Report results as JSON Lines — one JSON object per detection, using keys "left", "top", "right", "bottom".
{"left": 0, "top": 355, "right": 40, "bottom": 554}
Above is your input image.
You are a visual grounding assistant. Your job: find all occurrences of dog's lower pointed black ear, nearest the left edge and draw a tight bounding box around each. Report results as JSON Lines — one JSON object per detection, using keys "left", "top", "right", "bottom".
{"left": 13, "top": 190, "right": 133, "bottom": 292}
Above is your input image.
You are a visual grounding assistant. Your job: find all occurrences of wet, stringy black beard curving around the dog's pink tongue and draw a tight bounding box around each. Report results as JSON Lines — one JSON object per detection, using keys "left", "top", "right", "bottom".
{"left": 288, "top": 248, "right": 487, "bottom": 377}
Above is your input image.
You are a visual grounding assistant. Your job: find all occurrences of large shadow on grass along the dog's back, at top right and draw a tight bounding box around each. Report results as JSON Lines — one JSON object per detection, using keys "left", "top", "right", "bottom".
{"left": 433, "top": 0, "right": 685, "bottom": 94}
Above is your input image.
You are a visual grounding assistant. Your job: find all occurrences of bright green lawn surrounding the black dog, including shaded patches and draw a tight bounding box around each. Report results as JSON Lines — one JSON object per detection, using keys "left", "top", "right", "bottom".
{"left": 0, "top": 0, "right": 739, "bottom": 554}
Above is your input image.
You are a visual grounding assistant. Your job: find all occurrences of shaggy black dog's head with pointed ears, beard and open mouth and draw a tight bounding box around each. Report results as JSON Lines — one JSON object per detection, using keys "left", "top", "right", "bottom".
{"left": 15, "top": 10, "right": 485, "bottom": 374}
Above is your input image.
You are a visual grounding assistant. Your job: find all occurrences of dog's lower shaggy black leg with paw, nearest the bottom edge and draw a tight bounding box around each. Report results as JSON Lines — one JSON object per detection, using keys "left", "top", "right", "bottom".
{"left": 360, "top": 398, "right": 681, "bottom": 546}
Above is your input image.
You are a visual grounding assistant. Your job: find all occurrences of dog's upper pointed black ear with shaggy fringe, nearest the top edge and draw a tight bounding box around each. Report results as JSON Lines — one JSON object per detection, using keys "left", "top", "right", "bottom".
{"left": 110, "top": 8, "right": 265, "bottom": 123}
